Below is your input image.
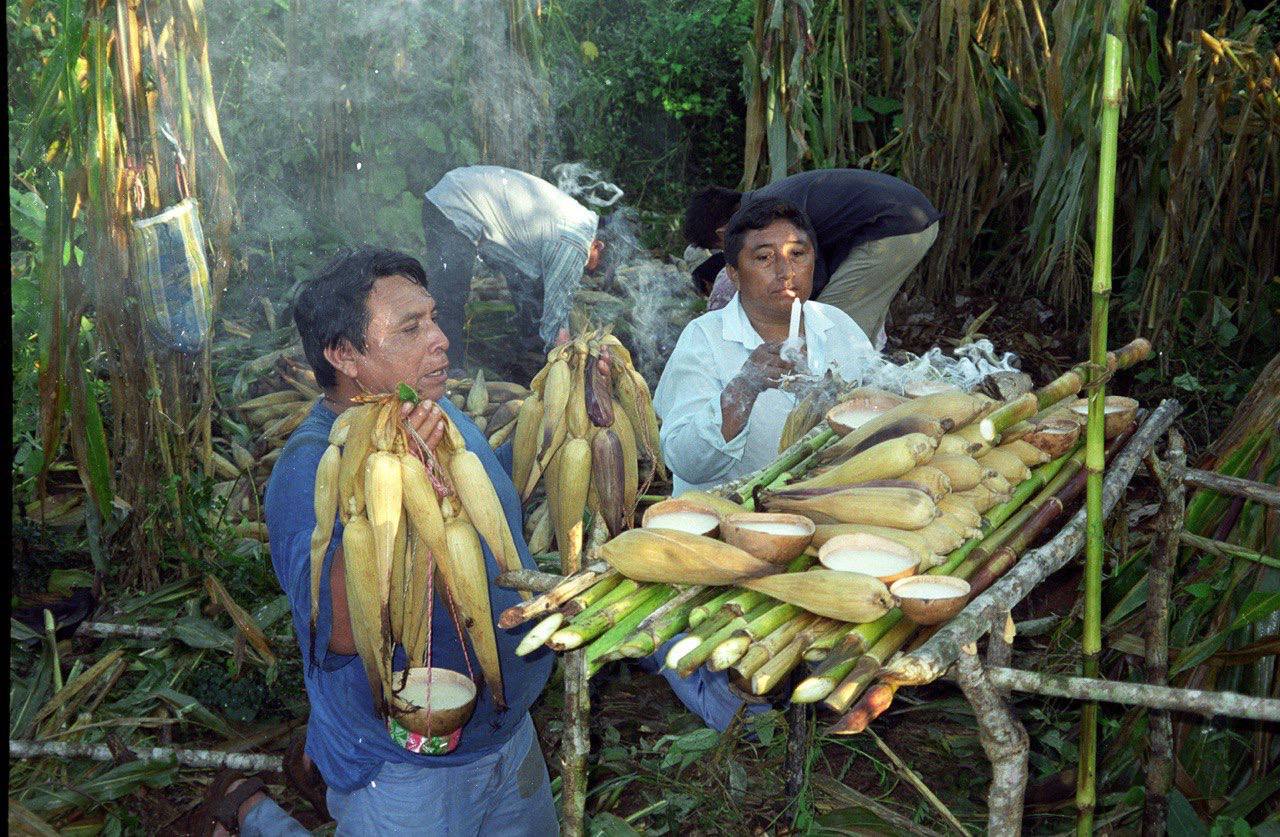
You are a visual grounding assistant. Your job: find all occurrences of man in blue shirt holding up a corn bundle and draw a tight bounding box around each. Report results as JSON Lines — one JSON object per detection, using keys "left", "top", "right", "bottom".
{"left": 194, "top": 248, "right": 558, "bottom": 837}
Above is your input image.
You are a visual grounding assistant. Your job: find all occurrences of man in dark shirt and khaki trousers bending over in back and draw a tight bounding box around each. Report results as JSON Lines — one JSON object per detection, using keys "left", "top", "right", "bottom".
{"left": 684, "top": 169, "right": 942, "bottom": 348}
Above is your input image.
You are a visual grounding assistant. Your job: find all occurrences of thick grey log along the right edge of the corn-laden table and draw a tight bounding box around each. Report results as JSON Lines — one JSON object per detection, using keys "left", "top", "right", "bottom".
{"left": 883, "top": 399, "right": 1181, "bottom": 686}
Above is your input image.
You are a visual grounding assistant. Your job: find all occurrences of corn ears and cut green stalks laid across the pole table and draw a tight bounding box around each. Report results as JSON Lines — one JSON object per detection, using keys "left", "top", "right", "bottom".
{"left": 503, "top": 340, "right": 1151, "bottom": 696}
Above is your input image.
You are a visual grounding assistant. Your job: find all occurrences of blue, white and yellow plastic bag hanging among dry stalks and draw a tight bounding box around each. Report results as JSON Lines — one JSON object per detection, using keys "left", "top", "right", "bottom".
{"left": 129, "top": 197, "right": 212, "bottom": 355}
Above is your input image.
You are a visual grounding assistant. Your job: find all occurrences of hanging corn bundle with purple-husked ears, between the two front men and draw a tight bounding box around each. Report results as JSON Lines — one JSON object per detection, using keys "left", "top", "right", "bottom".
{"left": 512, "top": 330, "right": 666, "bottom": 572}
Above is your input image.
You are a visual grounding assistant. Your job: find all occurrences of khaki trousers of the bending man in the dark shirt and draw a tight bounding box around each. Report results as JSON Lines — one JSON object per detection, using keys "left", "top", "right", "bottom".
{"left": 818, "top": 221, "right": 938, "bottom": 349}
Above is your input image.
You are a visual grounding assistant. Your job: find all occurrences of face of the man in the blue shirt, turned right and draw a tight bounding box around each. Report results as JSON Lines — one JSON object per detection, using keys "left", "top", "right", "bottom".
{"left": 353, "top": 276, "right": 449, "bottom": 401}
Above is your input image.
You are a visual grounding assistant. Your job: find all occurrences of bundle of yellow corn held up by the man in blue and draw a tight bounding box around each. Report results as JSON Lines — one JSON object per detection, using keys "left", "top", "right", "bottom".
{"left": 311, "top": 385, "right": 521, "bottom": 726}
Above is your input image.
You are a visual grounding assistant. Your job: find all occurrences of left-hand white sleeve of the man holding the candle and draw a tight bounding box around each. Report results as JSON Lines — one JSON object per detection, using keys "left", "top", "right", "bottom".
{"left": 654, "top": 330, "right": 748, "bottom": 484}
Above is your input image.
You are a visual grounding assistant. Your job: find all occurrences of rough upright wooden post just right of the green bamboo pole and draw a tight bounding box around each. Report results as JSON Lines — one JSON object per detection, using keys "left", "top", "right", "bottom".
{"left": 1142, "top": 430, "right": 1187, "bottom": 837}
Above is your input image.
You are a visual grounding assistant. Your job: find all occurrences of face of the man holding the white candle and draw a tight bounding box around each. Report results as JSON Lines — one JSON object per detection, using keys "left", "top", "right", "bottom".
{"left": 728, "top": 219, "right": 814, "bottom": 320}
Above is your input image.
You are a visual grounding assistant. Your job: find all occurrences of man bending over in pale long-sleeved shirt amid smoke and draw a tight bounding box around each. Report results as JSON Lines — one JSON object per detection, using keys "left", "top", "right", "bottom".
{"left": 422, "top": 165, "right": 605, "bottom": 367}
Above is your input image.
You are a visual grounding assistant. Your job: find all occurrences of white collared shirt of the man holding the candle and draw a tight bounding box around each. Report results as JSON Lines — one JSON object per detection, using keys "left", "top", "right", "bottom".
{"left": 653, "top": 296, "right": 879, "bottom": 495}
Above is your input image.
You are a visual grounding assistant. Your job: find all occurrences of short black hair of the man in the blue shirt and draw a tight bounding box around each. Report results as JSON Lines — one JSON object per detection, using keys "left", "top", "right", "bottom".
{"left": 293, "top": 246, "right": 426, "bottom": 389}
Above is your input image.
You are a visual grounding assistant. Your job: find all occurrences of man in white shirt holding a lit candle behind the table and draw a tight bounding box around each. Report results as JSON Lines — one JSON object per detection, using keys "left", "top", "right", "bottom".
{"left": 654, "top": 198, "right": 879, "bottom": 495}
